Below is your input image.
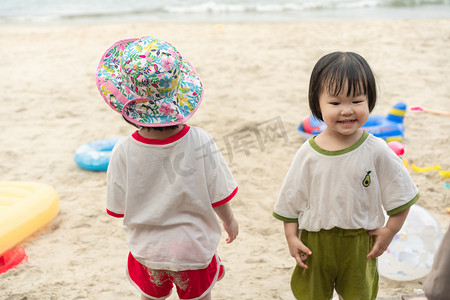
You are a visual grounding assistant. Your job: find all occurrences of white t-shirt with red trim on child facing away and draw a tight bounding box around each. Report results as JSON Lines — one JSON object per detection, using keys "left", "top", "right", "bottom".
{"left": 106, "top": 125, "right": 237, "bottom": 271}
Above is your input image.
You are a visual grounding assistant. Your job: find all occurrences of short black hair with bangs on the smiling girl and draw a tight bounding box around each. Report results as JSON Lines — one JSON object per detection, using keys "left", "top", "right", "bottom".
{"left": 308, "top": 52, "right": 377, "bottom": 121}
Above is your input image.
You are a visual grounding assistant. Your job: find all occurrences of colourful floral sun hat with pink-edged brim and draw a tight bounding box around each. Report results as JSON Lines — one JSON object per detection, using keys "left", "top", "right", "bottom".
{"left": 97, "top": 37, "right": 203, "bottom": 127}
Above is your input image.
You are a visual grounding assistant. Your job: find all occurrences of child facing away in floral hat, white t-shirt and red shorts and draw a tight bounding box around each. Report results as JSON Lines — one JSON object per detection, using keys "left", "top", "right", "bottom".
{"left": 97, "top": 37, "right": 239, "bottom": 299}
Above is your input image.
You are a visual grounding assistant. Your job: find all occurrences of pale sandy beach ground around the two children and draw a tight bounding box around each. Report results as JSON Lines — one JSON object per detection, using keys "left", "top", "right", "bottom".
{"left": 0, "top": 19, "right": 450, "bottom": 300}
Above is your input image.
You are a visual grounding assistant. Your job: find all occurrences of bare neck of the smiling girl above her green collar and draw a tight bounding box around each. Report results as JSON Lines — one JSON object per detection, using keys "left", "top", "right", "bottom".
{"left": 314, "top": 128, "right": 364, "bottom": 151}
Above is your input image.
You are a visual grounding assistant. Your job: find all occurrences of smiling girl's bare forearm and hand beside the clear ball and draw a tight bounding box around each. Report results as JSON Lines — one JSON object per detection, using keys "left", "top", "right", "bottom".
{"left": 367, "top": 208, "right": 409, "bottom": 258}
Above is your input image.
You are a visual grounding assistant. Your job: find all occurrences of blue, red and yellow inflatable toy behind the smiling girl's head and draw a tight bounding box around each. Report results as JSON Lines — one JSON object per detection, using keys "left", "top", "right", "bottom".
{"left": 298, "top": 102, "right": 406, "bottom": 142}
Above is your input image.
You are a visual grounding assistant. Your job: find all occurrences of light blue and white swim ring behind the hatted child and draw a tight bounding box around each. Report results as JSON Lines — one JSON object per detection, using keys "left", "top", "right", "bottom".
{"left": 74, "top": 137, "right": 120, "bottom": 171}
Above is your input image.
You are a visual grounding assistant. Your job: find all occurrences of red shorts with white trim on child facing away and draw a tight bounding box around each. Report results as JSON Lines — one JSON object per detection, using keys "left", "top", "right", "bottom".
{"left": 127, "top": 253, "right": 224, "bottom": 300}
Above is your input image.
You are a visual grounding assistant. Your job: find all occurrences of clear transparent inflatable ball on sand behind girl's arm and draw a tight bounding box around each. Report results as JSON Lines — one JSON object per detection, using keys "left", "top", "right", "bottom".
{"left": 378, "top": 204, "right": 442, "bottom": 281}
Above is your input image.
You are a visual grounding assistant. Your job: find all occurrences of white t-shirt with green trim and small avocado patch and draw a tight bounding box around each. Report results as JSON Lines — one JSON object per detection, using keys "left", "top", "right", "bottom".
{"left": 273, "top": 131, "right": 420, "bottom": 231}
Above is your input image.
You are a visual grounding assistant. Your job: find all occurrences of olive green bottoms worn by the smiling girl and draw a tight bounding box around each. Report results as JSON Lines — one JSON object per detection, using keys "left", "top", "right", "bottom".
{"left": 291, "top": 227, "right": 379, "bottom": 300}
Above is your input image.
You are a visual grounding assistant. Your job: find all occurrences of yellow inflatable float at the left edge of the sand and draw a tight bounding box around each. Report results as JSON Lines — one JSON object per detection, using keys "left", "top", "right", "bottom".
{"left": 0, "top": 181, "right": 59, "bottom": 257}
